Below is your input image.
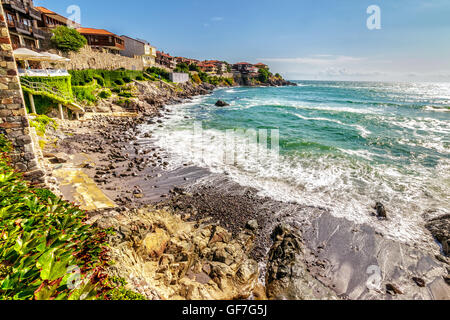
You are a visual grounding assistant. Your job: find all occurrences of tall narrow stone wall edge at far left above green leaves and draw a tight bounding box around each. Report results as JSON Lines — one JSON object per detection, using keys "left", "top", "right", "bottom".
{"left": 0, "top": 4, "right": 45, "bottom": 184}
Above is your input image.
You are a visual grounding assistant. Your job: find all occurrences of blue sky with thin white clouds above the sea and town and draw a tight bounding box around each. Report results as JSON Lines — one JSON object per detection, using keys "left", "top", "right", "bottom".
{"left": 34, "top": 0, "right": 450, "bottom": 82}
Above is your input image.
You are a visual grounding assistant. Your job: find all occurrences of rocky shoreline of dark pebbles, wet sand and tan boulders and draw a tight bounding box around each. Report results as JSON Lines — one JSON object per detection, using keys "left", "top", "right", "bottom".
{"left": 38, "top": 80, "right": 450, "bottom": 299}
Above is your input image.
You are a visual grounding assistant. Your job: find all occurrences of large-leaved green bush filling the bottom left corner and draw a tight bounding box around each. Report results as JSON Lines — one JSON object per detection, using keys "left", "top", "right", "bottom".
{"left": 0, "top": 135, "right": 111, "bottom": 300}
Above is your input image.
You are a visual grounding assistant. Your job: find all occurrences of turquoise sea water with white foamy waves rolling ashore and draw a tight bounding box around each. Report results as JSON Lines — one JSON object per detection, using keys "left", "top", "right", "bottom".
{"left": 146, "top": 81, "right": 450, "bottom": 240}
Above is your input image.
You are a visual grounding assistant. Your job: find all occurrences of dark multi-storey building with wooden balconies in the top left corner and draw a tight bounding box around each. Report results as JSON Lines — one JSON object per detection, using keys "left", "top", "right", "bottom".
{"left": 1, "top": 0, "right": 49, "bottom": 50}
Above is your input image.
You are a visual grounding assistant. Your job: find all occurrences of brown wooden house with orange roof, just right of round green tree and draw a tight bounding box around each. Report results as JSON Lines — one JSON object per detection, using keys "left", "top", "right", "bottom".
{"left": 77, "top": 28, "right": 125, "bottom": 54}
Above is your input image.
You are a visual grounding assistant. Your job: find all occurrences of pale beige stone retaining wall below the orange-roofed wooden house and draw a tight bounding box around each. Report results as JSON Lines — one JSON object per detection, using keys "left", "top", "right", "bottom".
{"left": 63, "top": 46, "right": 144, "bottom": 71}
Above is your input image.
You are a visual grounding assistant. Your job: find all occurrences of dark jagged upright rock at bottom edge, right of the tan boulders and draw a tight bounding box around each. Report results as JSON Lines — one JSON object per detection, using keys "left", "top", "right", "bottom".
{"left": 266, "top": 225, "right": 338, "bottom": 300}
